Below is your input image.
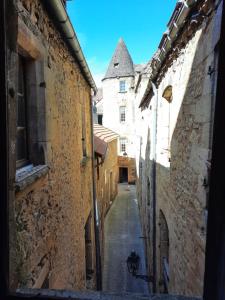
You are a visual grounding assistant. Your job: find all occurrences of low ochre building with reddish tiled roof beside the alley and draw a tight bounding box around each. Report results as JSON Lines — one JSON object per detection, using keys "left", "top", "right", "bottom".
{"left": 94, "top": 124, "right": 118, "bottom": 265}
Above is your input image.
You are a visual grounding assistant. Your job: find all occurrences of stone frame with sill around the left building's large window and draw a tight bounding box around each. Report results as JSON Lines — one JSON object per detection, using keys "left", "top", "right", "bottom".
{"left": 15, "top": 18, "right": 49, "bottom": 192}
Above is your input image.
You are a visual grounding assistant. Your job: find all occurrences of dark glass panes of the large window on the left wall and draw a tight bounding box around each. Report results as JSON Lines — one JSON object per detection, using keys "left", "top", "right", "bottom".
{"left": 16, "top": 55, "right": 28, "bottom": 168}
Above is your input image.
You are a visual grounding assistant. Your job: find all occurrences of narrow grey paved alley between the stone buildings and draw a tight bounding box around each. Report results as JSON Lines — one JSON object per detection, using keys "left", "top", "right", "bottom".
{"left": 103, "top": 184, "right": 149, "bottom": 294}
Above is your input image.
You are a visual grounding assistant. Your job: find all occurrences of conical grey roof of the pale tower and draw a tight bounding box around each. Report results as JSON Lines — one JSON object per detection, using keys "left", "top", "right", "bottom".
{"left": 103, "top": 38, "right": 134, "bottom": 80}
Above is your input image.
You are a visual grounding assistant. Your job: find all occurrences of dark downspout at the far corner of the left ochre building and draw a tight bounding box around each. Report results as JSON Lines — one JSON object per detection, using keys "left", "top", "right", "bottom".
{"left": 90, "top": 97, "right": 102, "bottom": 291}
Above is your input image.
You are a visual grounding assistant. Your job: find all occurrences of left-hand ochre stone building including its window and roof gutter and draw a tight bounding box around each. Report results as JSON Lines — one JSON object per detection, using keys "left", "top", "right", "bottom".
{"left": 8, "top": 0, "right": 99, "bottom": 290}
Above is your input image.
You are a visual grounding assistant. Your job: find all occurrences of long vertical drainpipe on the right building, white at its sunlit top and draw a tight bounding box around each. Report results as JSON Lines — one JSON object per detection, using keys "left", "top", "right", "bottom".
{"left": 152, "top": 82, "right": 158, "bottom": 293}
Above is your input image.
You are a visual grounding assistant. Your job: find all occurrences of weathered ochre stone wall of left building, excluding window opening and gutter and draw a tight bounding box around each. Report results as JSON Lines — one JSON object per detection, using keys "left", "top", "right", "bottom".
{"left": 10, "top": 0, "right": 95, "bottom": 290}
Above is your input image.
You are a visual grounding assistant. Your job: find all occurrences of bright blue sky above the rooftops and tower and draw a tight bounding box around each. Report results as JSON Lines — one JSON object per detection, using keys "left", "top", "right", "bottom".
{"left": 67, "top": 0, "right": 177, "bottom": 86}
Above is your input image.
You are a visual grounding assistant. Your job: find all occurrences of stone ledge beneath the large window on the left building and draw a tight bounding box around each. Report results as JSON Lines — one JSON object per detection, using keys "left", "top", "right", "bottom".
{"left": 15, "top": 165, "right": 49, "bottom": 192}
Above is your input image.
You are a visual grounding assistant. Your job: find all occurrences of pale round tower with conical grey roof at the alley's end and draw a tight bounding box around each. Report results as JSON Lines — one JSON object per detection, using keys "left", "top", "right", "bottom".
{"left": 102, "top": 39, "right": 141, "bottom": 183}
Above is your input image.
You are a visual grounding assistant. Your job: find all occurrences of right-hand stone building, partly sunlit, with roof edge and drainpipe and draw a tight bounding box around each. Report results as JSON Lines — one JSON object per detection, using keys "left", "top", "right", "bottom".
{"left": 136, "top": 0, "right": 222, "bottom": 296}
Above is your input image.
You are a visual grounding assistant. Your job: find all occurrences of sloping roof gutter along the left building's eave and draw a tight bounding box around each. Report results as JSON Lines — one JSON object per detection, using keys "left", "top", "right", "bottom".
{"left": 42, "top": 0, "right": 97, "bottom": 94}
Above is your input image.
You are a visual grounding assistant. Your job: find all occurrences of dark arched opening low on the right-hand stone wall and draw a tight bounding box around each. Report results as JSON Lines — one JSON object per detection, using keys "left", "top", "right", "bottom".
{"left": 159, "top": 210, "right": 169, "bottom": 293}
